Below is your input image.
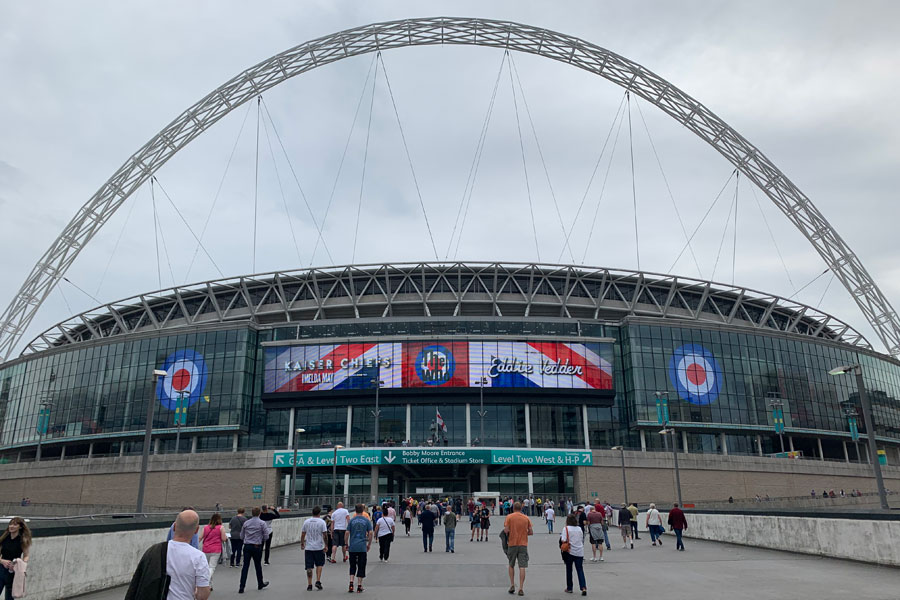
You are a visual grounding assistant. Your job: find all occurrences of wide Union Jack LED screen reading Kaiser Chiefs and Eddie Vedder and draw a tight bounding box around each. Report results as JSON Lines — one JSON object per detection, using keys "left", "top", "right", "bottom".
{"left": 263, "top": 340, "right": 613, "bottom": 394}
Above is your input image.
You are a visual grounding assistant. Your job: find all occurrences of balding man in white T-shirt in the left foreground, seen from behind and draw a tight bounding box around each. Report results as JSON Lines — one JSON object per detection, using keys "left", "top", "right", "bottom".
{"left": 165, "top": 510, "right": 210, "bottom": 600}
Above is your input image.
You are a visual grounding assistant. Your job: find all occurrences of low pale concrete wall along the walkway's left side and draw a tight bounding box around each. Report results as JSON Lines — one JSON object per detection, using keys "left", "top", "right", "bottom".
{"left": 28, "top": 519, "right": 305, "bottom": 600}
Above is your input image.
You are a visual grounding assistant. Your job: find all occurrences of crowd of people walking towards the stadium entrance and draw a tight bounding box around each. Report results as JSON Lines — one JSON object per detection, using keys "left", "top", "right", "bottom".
{"left": 123, "top": 497, "right": 687, "bottom": 600}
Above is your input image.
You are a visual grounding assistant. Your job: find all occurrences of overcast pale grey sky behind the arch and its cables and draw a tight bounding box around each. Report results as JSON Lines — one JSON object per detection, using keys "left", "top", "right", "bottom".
{"left": 0, "top": 0, "right": 900, "bottom": 356}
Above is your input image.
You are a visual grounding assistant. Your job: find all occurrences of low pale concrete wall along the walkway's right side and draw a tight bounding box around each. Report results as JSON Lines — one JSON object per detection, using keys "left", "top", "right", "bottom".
{"left": 660, "top": 512, "right": 900, "bottom": 567}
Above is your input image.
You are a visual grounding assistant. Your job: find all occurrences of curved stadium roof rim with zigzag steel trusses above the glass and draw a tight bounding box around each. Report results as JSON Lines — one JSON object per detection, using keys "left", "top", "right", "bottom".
{"left": 22, "top": 262, "right": 871, "bottom": 355}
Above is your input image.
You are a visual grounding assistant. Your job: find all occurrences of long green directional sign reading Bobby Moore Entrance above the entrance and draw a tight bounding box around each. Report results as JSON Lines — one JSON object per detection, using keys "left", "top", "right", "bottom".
{"left": 272, "top": 447, "right": 593, "bottom": 468}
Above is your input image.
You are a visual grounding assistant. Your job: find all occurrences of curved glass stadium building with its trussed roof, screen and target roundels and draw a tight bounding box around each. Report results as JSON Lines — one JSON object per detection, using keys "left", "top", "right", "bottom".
{"left": 0, "top": 263, "right": 900, "bottom": 502}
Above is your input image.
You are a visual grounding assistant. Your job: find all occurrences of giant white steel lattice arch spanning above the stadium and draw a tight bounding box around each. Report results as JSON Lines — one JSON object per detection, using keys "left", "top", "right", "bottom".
{"left": 0, "top": 17, "right": 900, "bottom": 361}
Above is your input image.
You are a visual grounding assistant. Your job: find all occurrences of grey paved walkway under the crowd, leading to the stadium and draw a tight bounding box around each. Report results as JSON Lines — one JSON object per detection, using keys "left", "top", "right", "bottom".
{"left": 81, "top": 516, "right": 900, "bottom": 600}
